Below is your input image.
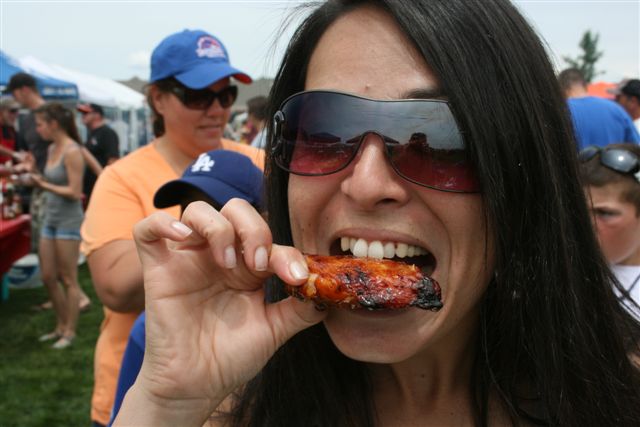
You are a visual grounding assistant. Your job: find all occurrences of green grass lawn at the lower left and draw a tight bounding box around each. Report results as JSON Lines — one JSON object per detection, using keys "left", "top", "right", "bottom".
{"left": 0, "top": 264, "right": 103, "bottom": 427}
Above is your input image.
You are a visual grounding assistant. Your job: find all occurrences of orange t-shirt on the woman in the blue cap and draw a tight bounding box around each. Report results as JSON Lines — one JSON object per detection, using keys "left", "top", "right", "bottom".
{"left": 80, "top": 139, "right": 264, "bottom": 425}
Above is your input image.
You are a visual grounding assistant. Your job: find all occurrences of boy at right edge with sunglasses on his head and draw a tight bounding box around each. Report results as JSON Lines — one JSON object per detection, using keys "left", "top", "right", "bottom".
{"left": 580, "top": 144, "right": 640, "bottom": 319}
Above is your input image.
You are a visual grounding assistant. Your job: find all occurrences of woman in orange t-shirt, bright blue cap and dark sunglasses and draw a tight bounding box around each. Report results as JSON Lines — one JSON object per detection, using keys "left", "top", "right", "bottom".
{"left": 82, "top": 30, "right": 264, "bottom": 425}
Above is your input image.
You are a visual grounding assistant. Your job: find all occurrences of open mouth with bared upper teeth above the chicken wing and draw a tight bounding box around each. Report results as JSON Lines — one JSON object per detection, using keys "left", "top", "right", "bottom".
{"left": 329, "top": 236, "right": 437, "bottom": 277}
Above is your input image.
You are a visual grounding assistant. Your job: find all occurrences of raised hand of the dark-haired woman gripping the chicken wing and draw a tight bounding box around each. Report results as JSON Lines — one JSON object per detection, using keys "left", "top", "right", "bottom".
{"left": 116, "top": 199, "right": 323, "bottom": 425}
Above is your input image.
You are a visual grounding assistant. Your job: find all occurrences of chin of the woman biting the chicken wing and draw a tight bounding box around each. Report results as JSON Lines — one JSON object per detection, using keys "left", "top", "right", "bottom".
{"left": 324, "top": 309, "right": 435, "bottom": 364}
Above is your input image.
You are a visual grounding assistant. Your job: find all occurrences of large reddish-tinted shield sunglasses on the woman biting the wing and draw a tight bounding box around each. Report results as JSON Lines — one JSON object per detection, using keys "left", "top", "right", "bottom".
{"left": 272, "top": 91, "right": 479, "bottom": 193}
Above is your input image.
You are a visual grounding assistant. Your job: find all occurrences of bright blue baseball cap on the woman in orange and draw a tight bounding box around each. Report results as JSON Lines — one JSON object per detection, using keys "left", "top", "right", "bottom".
{"left": 149, "top": 30, "right": 252, "bottom": 89}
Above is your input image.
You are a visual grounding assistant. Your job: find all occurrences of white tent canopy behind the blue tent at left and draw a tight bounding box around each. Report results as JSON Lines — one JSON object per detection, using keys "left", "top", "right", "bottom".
{"left": 18, "top": 56, "right": 144, "bottom": 110}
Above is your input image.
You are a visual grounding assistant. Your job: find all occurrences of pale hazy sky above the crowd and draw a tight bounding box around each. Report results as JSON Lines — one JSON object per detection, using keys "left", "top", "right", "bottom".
{"left": 0, "top": 0, "right": 640, "bottom": 82}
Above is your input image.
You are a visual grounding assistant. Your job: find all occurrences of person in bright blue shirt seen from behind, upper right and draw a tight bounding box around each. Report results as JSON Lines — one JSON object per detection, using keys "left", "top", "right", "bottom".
{"left": 558, "top": 68, "right": 640, "bottom": 150}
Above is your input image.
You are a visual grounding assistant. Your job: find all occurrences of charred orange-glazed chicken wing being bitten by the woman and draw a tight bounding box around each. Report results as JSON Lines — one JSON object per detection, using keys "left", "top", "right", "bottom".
{"left": 286, "top": 255, "right": 442, "bottom": 311}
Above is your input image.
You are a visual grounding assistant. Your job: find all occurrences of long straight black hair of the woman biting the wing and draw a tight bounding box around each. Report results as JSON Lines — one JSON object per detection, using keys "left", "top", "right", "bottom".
{"left": 232, "top": 0, "right": 640, "bottom": 426}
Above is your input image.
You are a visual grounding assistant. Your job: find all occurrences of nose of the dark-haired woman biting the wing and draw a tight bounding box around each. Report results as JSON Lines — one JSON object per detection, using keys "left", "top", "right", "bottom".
{"left": 340, "top": 133, "right": 409, "bottom": 210}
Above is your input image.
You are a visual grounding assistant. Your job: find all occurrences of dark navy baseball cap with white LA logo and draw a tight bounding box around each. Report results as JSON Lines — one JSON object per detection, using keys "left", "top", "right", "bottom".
{"left": 153, "top": 150, "right": 262, "bottom": 209}
